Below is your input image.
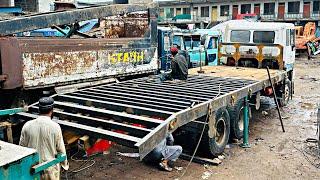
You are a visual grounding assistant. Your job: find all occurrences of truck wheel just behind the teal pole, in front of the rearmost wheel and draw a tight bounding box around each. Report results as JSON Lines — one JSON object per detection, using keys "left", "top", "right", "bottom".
{"left": 227, "top": 99, "right": 246, "bottom": 139}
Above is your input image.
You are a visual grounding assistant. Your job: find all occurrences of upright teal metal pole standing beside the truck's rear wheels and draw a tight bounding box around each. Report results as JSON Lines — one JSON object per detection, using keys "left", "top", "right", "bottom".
{"left": 240, "top": 96, "right": 251, "bottom": 148}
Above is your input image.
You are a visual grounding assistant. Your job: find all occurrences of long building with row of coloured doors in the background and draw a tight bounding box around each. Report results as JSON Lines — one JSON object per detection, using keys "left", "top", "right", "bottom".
{"left": 159, "top": 0, "right": 320, "bottom": 22}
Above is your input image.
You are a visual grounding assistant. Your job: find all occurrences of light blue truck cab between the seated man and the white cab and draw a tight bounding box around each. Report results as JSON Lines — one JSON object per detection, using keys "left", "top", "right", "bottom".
{"left": 182, "top": 29, "right": 221, "bottom": 67}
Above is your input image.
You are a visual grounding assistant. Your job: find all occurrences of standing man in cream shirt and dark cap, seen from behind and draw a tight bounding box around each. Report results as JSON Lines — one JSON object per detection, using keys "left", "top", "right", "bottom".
{"left": 19, "top": 97, "right": 69, "bottom": 179}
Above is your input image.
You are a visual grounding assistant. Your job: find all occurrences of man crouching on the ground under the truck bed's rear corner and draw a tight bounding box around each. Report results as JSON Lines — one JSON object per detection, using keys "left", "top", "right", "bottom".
{"left": 145, "top": 133, "right": 182, "bottom": 171}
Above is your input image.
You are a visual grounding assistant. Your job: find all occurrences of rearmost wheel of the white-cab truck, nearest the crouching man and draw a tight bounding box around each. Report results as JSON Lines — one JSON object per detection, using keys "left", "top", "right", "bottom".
{"left": 209, "top": 108, "right": 230, "bottom": 156}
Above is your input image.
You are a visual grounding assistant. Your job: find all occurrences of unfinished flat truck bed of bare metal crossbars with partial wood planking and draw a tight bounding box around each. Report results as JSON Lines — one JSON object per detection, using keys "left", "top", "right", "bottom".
{"left": 16, "top": 67, "right": 285, "bottom": 159}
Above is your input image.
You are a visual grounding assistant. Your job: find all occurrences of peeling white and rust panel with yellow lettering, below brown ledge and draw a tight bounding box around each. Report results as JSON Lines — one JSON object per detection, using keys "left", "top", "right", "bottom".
{"left": 22, "top": 44, "right": 158, "bottom": 88}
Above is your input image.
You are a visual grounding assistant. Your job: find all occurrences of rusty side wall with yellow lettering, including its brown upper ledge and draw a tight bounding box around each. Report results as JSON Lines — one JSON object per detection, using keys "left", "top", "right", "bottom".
{"left": 0, "top": 37, "right": 158, "bottom": 89}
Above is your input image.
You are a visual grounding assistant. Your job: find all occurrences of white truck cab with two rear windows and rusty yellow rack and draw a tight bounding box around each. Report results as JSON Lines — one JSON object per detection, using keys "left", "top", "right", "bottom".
{"left": 212, "top": 20, "right": 295, "bottom": 71}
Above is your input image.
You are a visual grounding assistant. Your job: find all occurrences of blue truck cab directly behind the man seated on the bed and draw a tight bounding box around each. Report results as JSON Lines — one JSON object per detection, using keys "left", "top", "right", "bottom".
{"left": 158, "top": 27, "right": 190, "bottom": 71}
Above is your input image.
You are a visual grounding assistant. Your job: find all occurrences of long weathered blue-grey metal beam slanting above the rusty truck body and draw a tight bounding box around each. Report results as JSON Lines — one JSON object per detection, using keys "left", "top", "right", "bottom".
{"left": 0, "top": 3, "right": 156, "bottom": 35}
